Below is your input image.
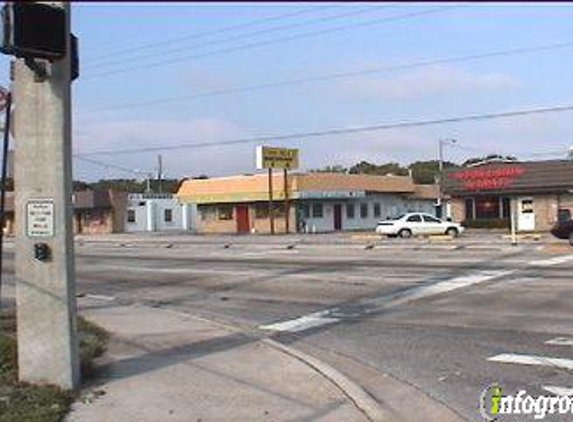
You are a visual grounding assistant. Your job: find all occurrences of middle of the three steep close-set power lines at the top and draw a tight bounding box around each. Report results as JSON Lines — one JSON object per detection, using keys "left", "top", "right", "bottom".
{"left": 86, "top": 4, "right": 392, "bottom": 71}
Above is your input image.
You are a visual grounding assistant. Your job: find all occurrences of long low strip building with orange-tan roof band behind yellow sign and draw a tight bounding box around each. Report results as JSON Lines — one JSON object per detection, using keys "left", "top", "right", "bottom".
{"left": 177, "top": 173, "right": 438, "bottom": 233}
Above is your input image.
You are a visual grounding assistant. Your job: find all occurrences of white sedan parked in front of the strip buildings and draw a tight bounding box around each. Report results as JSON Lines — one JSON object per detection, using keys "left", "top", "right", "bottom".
{"left": 376, "top": 213, "right": 464, "bottom": 238}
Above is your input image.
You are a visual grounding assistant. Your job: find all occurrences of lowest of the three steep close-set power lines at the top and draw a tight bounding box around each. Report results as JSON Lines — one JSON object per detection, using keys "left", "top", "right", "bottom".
{"left": 83, "top": 6, "right": 467, "bottom": 80}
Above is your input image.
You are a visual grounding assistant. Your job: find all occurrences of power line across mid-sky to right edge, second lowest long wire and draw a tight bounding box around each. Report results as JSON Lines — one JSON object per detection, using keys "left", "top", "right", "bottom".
{"left": 81, "top": 41, "right": 573, "bottom": 113}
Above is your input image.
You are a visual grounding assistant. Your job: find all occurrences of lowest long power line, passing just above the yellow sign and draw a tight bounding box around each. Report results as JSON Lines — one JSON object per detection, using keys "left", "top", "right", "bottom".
{"left": 77, "top": 105, "right": 573, "bottom": 157}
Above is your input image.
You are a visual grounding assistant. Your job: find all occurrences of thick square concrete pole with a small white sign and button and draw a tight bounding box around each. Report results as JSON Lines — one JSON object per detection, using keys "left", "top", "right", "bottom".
{"left": 13, "top": 2, "right": 80, "bottom": 389}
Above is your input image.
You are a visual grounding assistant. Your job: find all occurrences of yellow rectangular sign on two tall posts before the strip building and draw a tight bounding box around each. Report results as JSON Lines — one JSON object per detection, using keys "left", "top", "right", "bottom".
{"left": 256, "top": 146, "right": 299, "bottom": 234}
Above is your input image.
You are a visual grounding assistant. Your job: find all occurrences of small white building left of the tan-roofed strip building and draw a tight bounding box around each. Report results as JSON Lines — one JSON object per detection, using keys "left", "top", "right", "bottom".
{"left": 125, "top": 193, "right": 196, "bottom": 233}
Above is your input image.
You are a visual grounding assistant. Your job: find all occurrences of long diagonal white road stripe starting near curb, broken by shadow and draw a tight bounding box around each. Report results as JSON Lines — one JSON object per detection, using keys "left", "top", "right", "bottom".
{"left": 259, "top": 270, "right": 515, "bottom": 333}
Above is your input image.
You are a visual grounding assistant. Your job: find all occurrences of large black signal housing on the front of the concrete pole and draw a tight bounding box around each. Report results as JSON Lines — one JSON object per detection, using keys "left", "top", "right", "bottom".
{"left": 0, "top": 1, "right": 68, "bottom": 60}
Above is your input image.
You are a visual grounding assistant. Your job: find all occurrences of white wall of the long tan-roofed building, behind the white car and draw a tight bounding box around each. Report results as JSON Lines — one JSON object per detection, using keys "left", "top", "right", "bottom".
{"left": 304, "top": 194, "right": 435, "bottom": 233}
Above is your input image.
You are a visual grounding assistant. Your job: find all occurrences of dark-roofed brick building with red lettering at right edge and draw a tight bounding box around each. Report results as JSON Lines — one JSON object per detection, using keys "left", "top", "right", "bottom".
{"left": 444, "top": 160, "right": 573, "bottom": 232}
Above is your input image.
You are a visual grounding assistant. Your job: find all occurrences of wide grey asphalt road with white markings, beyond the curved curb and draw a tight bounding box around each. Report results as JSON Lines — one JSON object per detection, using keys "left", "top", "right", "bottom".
{"left": 1, "top": 239, "right": 573, "bottom": 421}
